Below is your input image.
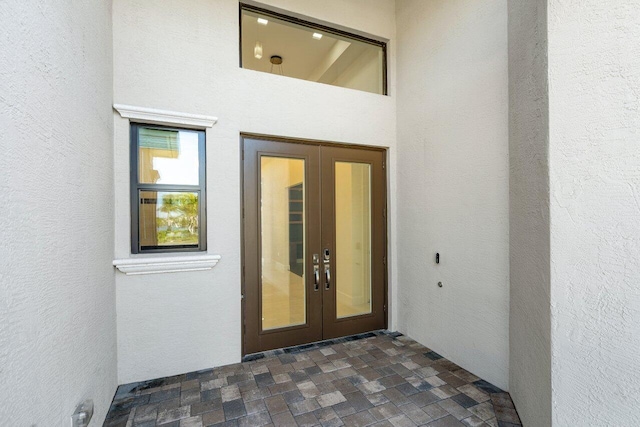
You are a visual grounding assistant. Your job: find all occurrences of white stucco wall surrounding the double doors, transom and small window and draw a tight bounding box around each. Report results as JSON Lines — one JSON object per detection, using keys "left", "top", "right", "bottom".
{"left": 113, "top": 0, "right": 397, "bottom": 383}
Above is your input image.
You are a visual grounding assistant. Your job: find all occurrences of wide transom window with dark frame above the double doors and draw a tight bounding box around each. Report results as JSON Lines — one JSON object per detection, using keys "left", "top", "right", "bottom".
{"left": 240, "top": 4, "right": 387, "bottom": 95}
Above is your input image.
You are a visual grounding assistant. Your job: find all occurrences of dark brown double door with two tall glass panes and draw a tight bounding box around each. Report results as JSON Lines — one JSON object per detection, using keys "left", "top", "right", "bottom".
{"left": 243, "top": 136, "right": 386, "bottom": 354}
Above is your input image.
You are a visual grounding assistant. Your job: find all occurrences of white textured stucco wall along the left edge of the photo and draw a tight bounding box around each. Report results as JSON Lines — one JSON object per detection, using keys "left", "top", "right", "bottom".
{"left": 0, "top": 0, "right": 116, "bottom": 426}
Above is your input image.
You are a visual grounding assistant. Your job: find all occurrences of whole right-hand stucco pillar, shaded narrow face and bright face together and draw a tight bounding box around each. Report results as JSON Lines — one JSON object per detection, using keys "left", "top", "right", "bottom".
{"left": 509, "top": 0, "right": 640, "bottom": 426}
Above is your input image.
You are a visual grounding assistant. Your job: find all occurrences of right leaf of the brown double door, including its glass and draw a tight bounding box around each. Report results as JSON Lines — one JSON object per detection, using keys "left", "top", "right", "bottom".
{"left": 321, "top": 147, "right": 386, "bottom": 339}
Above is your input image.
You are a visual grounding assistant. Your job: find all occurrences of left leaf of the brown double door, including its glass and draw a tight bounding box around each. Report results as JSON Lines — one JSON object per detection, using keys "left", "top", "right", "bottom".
{"left": 242, "top": 137, "right": 323, "bottom": 354}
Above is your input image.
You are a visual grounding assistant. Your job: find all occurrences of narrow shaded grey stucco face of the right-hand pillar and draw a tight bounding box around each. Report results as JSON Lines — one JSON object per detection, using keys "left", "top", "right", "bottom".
{"left": 509, "top": 0, "right": 551, "bottom": 427}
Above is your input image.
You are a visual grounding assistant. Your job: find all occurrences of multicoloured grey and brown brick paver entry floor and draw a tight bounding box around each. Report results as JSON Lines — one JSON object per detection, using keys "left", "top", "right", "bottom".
{"left": 104, "top": 332, "right": 520, "bottom": 427}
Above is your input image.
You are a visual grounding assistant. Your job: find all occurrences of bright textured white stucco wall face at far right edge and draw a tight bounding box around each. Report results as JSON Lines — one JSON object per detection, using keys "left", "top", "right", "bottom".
{"left": 548, "top": 0, "right": 640, "bottom": 426}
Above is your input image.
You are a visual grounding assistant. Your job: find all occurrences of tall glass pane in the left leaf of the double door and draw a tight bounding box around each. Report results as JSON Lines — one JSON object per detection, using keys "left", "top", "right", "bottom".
{"left": 260, "top": 156, "right": 306, "bottom": 330}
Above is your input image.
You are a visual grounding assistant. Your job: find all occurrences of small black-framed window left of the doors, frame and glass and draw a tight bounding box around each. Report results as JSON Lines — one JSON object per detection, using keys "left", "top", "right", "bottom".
{"left": 131, "top": 123, "right": 207, "bottom": 254}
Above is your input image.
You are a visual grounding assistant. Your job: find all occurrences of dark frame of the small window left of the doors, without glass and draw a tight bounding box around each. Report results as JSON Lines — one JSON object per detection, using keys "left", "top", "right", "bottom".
{"left": 129, "top": 122, "right": 207, "bottom": 254}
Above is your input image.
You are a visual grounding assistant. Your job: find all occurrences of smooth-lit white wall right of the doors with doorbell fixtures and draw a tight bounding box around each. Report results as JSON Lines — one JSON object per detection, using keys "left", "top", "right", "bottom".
{"left": 396, "top": 0, "right": 509, "bottom": 389}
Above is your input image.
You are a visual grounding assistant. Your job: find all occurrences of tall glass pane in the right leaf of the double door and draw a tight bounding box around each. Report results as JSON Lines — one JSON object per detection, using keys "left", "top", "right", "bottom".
{"left": 335, "top": 162, "right": 371, "bottom": 318}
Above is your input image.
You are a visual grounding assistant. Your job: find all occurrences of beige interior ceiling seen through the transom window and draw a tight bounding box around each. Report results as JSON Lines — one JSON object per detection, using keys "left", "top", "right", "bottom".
{"left": 242, "top": 11, "right": 364, "bottom": 81}
